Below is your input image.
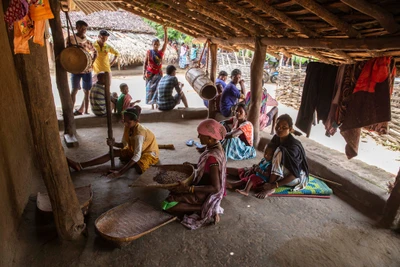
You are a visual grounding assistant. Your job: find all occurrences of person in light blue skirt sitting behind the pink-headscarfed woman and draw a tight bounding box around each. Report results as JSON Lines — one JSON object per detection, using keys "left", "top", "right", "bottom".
{"left": 221, "top": 103, "right": 256, "bottom": 160}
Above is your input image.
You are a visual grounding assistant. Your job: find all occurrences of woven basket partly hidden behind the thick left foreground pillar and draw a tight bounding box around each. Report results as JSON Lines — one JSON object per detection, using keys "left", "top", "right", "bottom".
{"left": 36, "top": 184, "right": 93, "bottom": 215}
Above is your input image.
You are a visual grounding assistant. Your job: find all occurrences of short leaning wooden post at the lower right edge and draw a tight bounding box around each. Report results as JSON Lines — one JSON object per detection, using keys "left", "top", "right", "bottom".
{"left": 380, "top": 169, "right": 400, "bottom": 230}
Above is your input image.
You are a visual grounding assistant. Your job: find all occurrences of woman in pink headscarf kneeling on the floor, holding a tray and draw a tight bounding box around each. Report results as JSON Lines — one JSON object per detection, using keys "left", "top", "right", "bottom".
{"left": 163, "top": 119, "right": 226, "bottom": 229}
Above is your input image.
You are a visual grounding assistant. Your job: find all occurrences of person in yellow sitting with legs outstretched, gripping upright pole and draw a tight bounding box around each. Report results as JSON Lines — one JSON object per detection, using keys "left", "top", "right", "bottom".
{"left": 67, "top": 106, "right": 159, "bottom": 178}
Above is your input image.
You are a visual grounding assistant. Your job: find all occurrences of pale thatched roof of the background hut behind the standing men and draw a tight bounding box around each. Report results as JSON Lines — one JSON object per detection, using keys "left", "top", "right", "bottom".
{"left": 61, "top": 10, "right": 156, "bottom": 35}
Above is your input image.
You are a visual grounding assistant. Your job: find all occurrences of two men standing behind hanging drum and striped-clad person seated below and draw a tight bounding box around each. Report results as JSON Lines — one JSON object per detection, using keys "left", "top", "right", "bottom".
{"left": 65, "top": 20, "right": 120, "bottom": 115}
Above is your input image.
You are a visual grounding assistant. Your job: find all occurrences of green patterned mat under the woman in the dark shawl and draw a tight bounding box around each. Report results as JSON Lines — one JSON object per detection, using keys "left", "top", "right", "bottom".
{"left": 272, "top": 175, "right": 333, "bottom": 196}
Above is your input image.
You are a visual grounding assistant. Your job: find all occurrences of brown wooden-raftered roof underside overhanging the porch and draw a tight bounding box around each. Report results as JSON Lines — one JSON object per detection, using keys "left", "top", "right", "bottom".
{"left": 69, "top": 0, "right": 400, "bottom": 64}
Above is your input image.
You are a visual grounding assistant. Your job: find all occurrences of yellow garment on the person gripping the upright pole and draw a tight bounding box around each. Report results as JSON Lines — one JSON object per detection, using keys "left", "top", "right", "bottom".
{"left": 121, "top": 123, "right": 160, "bottom": 171}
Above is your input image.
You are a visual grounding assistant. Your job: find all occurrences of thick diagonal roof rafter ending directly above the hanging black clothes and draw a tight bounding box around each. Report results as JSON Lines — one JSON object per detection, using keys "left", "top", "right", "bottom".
{"left": 248, "top": 0, "right": 318, "bottom": 37}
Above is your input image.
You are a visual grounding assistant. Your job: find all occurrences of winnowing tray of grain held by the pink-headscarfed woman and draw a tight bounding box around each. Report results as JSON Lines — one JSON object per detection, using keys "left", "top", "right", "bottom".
{"left": 130, "top": 164, "right": 194, "bottom": 189}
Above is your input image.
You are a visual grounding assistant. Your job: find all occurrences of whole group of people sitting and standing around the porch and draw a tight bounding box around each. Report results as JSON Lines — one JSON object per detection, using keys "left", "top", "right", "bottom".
{"left": 67, "top": 23, "right": 308, "bottom": 229}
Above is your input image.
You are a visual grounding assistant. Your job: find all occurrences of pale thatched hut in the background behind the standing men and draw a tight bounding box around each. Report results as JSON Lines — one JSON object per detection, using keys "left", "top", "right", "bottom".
{"left": 61, "top": 10, "right": 177, "bottom": 66}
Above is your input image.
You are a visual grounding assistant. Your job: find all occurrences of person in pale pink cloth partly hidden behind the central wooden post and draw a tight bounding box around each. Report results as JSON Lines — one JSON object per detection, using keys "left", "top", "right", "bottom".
{"left": 245, "top": 80, "right": 278, "bottom": 134}
